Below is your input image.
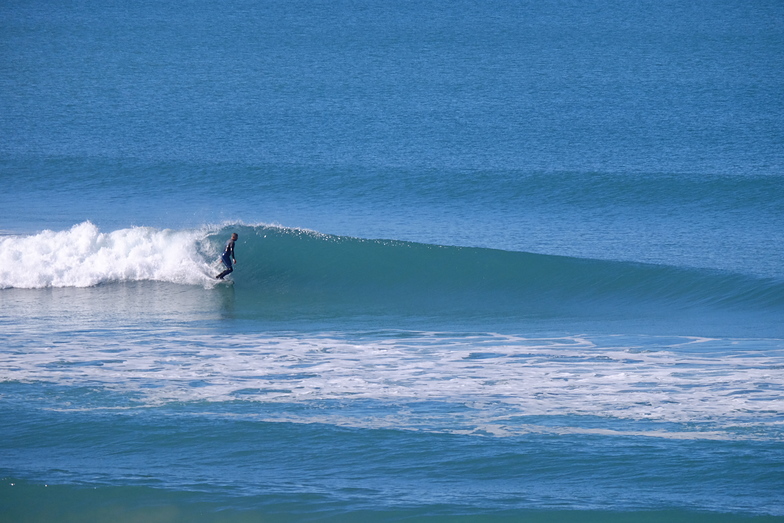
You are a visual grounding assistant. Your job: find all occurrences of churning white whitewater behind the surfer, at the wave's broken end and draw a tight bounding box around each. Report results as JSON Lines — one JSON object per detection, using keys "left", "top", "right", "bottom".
{"left": 0, "top": 222, "right": 217, "bottom": 289}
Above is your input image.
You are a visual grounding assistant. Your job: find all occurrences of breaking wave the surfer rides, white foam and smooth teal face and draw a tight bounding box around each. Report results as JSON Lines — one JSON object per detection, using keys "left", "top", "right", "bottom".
{"left": 0, "top": 222, "right": 784, "bottom": 312}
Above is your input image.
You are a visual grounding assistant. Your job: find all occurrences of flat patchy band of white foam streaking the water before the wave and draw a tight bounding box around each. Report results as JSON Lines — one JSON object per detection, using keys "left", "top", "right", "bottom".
{"left": 0, "top": 333, "right": 784, "bottom": 438}
